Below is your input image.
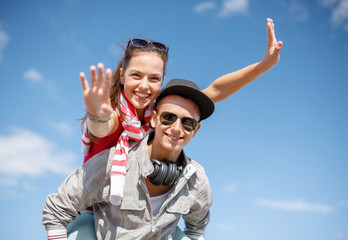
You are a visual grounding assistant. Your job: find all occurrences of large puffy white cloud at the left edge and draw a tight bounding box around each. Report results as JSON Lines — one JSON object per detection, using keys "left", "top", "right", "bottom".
{"left": 0, "top": 129, "right": 77, "bottom": 179}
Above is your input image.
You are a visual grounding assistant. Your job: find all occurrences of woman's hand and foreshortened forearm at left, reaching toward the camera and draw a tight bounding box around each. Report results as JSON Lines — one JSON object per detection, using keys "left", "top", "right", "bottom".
{"left": 80, "top": 63, "right": 120, "bottom": 138}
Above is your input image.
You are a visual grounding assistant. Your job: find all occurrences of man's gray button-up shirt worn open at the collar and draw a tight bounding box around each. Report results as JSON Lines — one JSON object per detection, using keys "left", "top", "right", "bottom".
{"left": 42, "top": 137, "right": 212, "bottom": 239}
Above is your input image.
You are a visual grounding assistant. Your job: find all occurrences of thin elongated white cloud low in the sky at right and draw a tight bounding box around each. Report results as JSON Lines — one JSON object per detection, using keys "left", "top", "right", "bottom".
{"left": 256, "top": 199, "right": 334, "bottom": 214}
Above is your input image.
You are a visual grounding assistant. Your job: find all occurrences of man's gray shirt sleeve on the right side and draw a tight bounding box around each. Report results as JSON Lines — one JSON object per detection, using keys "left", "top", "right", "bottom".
{"left": 183, "top": 166, "right": 212, "bottom": 240}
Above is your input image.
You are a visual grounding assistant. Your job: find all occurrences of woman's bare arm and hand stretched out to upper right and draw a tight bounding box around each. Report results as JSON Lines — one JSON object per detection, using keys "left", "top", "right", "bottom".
{"left": 202, "top": 18, "right": 283, "bottom": 103}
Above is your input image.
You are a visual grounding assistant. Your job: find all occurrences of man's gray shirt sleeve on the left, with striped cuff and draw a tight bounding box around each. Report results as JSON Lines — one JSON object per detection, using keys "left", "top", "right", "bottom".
{"left": 42, "top": 150, "right": 110, "bottom": 240}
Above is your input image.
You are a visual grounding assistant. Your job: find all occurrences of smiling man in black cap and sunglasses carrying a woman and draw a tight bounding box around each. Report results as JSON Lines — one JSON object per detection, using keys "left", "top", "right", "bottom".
{"left": 42, "top": 79, "right": 214, "bottom": 239}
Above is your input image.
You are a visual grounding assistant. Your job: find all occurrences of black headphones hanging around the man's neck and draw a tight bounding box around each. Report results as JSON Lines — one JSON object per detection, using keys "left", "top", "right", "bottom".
{"left": 147, "top": 159, "right": 182, "bottom": 186}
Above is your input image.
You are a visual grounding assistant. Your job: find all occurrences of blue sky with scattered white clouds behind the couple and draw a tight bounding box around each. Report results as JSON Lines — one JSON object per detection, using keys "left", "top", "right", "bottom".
{"left": 0, "top": 0, "right": 348, "bottom": 240}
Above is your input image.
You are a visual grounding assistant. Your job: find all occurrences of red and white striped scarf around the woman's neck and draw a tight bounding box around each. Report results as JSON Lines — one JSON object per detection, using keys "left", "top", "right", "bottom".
{"left": 82, "top": 91, "right": 155, "bottom": 205}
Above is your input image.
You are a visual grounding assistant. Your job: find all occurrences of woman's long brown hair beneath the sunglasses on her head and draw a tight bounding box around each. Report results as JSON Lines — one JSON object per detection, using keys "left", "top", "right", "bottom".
{"left": 81, "top": 39, "right": 168, "bottom": 141}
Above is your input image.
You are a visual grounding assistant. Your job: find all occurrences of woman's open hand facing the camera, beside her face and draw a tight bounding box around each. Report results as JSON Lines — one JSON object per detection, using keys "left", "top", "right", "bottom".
{"left": 80, "top": 63, "right": 113, "bottom": 119}
